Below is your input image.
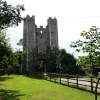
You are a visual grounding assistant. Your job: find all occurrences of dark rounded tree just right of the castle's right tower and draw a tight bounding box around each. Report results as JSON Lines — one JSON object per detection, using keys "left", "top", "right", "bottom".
{"left": 60, "top": 49, "right": 83, "bottom": 74}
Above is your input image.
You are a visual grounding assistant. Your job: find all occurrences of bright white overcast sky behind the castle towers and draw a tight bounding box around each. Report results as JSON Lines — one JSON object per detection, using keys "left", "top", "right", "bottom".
{"left": 6, "top": 0, "right": 100, "bottom": 57}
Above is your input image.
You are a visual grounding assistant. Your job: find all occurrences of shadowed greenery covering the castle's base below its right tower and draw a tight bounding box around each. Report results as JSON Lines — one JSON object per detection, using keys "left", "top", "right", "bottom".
{"left": 35, "top": 47, "right": 59, "bottom": 73}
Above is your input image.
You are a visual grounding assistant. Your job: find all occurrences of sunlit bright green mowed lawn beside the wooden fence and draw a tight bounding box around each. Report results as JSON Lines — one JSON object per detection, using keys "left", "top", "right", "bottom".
{"left": 0, "top": 75, "right": 100, "bottom": 100}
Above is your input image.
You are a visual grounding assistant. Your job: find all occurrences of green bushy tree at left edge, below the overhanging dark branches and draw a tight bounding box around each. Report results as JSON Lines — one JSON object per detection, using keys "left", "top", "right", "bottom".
{"left": 0, "top": 31, "right": 19, "bottom": 73}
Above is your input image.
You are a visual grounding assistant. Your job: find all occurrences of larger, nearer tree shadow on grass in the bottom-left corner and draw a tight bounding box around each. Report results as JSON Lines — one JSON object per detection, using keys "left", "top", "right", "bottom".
{"left": 0, "top": 89, "right": 25, "bottom": 100}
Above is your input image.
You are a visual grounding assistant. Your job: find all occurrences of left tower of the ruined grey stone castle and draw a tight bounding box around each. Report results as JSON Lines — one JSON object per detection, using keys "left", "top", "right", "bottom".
{"left": 23, "top": 15, "right": 36, "bottom": 71}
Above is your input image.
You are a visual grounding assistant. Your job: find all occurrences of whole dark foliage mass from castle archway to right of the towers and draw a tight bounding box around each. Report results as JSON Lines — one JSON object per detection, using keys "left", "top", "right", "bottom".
{"left": 36, "top": 48, "right": 82, "bottom": 74}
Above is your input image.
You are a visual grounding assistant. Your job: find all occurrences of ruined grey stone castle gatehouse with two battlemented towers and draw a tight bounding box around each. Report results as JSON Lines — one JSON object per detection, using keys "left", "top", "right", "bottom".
{"left": 22, "top": 15, "right": 58, "bottom": 72}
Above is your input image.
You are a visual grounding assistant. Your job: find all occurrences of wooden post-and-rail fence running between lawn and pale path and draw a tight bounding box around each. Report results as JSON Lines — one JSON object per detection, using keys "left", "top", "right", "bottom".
{"left": 44, "top": 73, "right": 100, "bottom": 94}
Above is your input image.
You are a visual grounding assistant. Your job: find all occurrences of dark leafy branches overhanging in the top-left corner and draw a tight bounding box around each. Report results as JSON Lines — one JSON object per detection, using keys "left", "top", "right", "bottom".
{"left": 0, "top": 1, "right": 25, "bottom": 29}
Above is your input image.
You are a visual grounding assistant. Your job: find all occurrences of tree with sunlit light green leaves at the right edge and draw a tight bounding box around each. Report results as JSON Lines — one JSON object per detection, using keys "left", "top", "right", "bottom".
{"left": 70, "top": 26, "right": 100, "bottom": 67}
